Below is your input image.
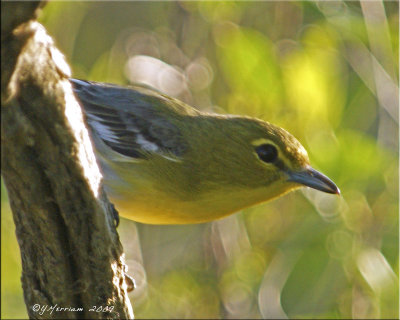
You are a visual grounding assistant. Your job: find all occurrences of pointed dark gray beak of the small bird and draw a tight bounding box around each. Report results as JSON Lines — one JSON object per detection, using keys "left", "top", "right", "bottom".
{"left": 288, "top": 167, "right": 340, "bottom": 195}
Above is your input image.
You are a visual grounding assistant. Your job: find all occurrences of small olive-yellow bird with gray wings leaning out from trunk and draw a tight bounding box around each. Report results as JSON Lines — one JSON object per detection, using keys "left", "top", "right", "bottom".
{"left": 70, "top": 78, "right": 340, "bottom": 224}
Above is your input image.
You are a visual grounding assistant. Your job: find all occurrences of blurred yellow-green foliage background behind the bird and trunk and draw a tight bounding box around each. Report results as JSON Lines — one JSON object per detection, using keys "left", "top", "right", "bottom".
{"left": 1, "top": 1, "right": 399, "bottom": 318}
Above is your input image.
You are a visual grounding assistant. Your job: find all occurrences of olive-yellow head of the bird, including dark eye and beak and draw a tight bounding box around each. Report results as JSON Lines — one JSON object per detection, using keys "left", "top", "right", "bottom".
{"left": 189, "top": 116, "right": 340, "bottom": 202}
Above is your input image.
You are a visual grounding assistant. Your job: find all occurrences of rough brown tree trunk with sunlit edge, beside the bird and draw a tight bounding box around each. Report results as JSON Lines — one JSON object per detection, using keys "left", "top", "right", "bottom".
{"left": 1, "top": 1, "right": 133, "bottom": 319}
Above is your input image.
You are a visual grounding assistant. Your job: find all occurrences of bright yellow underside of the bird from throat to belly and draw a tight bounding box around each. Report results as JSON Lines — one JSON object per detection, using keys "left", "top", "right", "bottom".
{"left": 106, "top": 178, "right": 296, "bottom": 224}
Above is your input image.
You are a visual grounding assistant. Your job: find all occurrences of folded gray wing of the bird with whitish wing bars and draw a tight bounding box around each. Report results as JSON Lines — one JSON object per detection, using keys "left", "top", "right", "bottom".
{"left": 70, "top": 79, "right": 186, "bottom": 159}
